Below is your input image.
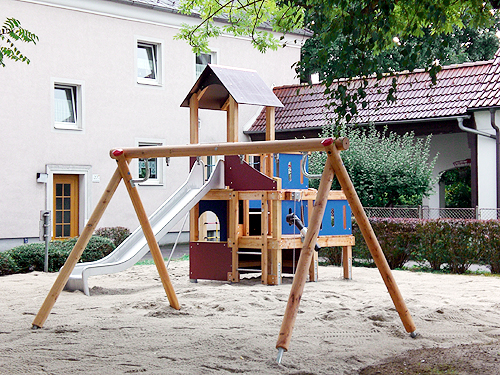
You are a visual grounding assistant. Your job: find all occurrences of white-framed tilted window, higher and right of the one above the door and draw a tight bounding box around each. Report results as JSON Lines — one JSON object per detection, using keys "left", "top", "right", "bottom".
{"left": 137, "top": 41, "right": 161, "bottom": 85}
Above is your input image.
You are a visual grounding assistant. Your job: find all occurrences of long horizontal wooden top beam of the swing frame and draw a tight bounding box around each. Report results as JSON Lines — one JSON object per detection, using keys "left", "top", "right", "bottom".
{"left": 110, "top": 138, "right": 349, "bottom": 159}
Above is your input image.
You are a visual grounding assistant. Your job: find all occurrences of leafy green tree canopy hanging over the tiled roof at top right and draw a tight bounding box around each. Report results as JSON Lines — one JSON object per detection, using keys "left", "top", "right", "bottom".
{"left": 178, "top": 0, "right": 500, "bottom": 123}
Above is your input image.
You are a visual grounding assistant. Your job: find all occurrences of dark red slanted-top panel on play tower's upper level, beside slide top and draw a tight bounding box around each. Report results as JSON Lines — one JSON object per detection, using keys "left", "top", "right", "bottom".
{"left": 224, "top": 155, "right": 276, "bottom": 190}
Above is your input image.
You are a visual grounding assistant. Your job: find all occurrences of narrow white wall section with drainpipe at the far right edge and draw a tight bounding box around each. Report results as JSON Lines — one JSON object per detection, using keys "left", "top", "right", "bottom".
{"left": 474, "top": 111, "right": 500, "bottom": 208}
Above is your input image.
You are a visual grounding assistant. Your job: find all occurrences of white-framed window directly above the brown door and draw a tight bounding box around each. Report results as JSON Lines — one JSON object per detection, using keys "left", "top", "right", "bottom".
{"left": 53, "top": 82, "right": 83, "bottom": 130}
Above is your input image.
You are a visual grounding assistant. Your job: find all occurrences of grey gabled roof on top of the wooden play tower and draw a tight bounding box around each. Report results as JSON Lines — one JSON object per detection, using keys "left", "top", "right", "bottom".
{"left": 181, "top": 64, "right": 283, "bottom": 110}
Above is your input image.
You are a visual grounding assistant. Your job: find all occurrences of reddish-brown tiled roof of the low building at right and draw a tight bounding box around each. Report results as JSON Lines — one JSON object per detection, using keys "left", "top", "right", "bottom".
{"left": 248, "top": 50, "right": 500, "bottom": 132}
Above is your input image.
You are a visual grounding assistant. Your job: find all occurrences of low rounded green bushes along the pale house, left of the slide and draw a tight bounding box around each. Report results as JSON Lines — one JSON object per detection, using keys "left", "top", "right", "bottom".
{"left": 0, "top": 236, "right": 115, "bottom": 276}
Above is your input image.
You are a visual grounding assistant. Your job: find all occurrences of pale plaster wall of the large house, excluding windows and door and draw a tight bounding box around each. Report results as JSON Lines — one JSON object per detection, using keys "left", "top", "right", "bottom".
{"left": 0, "top": 0, "right": 300, "bottom": 248}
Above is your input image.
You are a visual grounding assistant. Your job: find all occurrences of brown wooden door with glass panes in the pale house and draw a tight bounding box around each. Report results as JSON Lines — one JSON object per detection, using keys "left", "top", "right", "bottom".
{"left": 52, "top": 174, "right": 78, "bottom": 239}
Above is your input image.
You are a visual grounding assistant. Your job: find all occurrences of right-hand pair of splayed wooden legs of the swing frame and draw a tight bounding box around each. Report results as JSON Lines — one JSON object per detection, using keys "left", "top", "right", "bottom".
{"left": 276, "top": 138, "right": 416, "bottom": 363}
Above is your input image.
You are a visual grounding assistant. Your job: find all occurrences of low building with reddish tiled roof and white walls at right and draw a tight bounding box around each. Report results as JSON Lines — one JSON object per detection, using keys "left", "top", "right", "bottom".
{"left": 245, "top": 51, "right": 500, "bottom": 213}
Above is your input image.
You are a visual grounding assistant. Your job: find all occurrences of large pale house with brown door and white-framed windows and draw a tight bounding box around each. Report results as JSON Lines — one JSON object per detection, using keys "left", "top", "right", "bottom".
{"left": 0, "top": 0, "right": 303, "bottom": 250}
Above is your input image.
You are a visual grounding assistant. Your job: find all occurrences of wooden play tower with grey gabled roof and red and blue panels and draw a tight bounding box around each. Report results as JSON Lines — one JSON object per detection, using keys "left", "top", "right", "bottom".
{"left": 182, "top": 65, "right": 354, "bottom": 285}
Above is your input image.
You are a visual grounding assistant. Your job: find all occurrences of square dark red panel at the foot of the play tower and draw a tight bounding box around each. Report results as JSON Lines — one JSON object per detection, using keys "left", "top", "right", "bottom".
{"left": 189, "top": 242, "right": 232, "bottom": 281}
